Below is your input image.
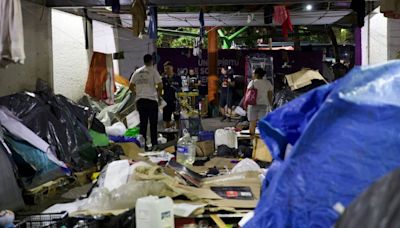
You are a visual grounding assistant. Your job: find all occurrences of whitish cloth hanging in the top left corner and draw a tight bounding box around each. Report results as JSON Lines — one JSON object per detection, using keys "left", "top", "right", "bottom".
{"left": 0, "top": 0, "right": 25, "bottom": 67}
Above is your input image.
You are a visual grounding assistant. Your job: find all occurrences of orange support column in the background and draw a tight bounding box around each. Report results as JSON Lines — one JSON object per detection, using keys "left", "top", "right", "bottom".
{"left": 207, "top": 28, "right": 218, "bottom": 104}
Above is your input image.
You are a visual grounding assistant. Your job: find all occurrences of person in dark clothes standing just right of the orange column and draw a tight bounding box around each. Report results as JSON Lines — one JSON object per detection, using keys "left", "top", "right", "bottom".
{"left": 219, "top": 67, "right": 235, "bottom": 121}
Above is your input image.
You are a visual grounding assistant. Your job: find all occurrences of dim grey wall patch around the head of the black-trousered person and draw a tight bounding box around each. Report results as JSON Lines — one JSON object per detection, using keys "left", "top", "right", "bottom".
{"left": 116, "top": 29, "right": 155, "bottom": 79}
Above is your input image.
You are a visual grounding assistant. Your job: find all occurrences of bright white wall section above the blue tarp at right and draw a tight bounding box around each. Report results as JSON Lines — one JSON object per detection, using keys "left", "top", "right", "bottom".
{"left": 361, "top": 7, "right": 388, "bottom": 65}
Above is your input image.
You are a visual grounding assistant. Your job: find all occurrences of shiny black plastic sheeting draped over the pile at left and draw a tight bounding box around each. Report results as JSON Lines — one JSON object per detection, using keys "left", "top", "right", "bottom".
{"left": 0, "top": 92, "right": 104, "bottom": 171}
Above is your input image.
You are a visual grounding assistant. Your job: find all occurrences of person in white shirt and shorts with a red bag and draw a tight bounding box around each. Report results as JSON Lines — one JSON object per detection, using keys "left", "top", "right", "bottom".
{"left": 247, "top": 68, "right": 274, "bottom": 136}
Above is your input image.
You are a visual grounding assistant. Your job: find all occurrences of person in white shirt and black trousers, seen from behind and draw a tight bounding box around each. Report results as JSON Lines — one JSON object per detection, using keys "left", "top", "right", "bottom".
{"left": 129, "top": 54, "right": 163, "bottom": 147}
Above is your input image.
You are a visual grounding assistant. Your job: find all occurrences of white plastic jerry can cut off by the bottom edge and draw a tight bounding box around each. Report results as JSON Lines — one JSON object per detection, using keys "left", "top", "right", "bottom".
{"left": 135, "top": 196, "right": 175, "bottom": 228}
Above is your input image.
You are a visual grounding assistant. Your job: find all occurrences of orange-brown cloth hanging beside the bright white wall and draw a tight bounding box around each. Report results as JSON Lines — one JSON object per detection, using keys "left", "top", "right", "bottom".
{"left": 85, "top": 52, "right": 115, "bottom": 104}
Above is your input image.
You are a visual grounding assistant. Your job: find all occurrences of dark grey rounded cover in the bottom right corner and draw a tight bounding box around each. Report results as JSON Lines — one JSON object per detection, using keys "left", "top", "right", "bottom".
{"left": 335, "top": 169, "right": 400, "bottom": 228}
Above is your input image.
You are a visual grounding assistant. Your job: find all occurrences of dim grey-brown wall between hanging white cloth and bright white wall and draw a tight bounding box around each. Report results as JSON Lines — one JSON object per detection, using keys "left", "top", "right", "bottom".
{"left": 0, "top": 1, "right": 52, "bottom": 96}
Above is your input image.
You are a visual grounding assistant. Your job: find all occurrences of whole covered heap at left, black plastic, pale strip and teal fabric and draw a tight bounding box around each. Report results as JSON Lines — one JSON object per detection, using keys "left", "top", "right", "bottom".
{"left": 0, "top": 83, "right": 114, "bottom": 209}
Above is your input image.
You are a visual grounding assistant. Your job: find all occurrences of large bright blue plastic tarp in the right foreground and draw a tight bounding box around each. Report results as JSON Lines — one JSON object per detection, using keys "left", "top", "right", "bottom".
{"left": 246, "top": 61, "right": 400, "bottom": 227}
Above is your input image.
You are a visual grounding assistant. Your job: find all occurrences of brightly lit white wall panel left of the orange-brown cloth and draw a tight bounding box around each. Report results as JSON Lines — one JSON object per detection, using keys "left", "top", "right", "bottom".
{"left": 52, "top": 9, "right": 91, "bottom": 100}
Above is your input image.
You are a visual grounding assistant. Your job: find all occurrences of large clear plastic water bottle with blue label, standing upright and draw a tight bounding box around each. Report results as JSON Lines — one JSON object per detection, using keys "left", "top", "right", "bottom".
{"left": 176, "top": 129, "right": 194, "bottom": 166}
